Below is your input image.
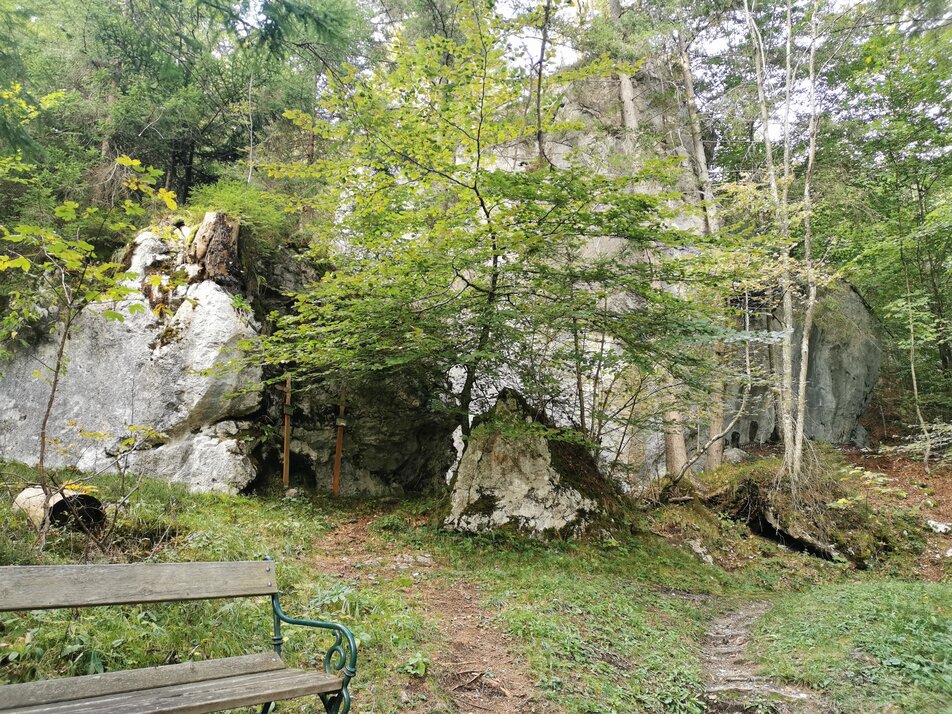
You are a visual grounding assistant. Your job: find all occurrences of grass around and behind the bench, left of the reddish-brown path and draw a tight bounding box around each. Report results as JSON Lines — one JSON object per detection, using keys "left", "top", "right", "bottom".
{"left": 0, "top": 468, "right": 434, "bottom": 712}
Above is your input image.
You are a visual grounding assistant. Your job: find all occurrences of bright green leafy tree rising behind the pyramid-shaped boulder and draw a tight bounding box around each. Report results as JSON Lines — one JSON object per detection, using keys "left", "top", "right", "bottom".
{"left": 260, "top": 2, "right": 705, "bottom": 458}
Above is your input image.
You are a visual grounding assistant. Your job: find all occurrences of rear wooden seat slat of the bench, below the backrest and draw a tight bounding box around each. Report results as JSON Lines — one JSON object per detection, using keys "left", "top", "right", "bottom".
{"left": 0, "top": 652, "right": 284, "bottom": 714}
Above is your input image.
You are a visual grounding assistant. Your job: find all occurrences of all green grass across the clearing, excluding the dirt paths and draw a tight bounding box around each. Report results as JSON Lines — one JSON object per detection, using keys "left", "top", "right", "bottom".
{"left": 0, "top": 469, "right": 952, "bottom": 714}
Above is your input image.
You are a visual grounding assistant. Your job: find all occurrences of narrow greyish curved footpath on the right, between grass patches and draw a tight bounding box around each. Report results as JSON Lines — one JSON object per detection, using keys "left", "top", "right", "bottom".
{"left": 703, "top": 602, "right": 824, "bottom": 714}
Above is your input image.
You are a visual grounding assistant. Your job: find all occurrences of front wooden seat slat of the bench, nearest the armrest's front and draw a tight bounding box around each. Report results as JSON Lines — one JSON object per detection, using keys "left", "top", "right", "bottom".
{"left": 12, "top": 669, "right": 341, "bottom": 714}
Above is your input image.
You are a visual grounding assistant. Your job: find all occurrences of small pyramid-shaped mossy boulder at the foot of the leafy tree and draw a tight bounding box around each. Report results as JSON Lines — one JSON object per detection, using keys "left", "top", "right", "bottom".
{"left": 445, "top": 390, "right": 601, "bottom": 534}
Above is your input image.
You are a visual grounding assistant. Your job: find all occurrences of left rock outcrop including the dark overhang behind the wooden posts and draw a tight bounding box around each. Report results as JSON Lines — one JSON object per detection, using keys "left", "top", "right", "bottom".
{"left": 0, "top": 213, "right": 455, "bottom": 495}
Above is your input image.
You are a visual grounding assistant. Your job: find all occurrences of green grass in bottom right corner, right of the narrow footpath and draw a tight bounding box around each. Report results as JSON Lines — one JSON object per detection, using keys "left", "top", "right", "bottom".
{"left": 754, "top": 581, "right": 952, "bottom": 713}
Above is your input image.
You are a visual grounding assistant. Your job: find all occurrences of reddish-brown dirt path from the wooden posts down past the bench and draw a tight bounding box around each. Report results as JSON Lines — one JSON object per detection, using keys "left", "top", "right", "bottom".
{"left": 311, "top": 516, "right": 561, "bottom": 714}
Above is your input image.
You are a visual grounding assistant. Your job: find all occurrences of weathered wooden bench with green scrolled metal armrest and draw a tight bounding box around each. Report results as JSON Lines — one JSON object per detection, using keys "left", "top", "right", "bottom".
{"left": 0, "top": 560, "right": 357, "bottom": 714}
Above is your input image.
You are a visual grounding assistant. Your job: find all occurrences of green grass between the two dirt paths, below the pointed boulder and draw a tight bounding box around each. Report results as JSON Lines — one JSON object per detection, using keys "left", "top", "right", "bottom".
{"left": 386, "top": 529, "right": 737, "bottom": 714}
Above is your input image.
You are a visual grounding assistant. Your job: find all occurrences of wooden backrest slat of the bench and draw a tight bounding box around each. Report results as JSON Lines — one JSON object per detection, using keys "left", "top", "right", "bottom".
{"left": 0, "top": 560, "right": 277, "bottom": 611}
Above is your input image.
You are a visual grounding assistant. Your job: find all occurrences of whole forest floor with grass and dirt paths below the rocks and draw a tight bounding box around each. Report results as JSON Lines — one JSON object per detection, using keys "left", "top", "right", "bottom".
{"left": 0, "top": 454, "right": 952, "bottom": 714}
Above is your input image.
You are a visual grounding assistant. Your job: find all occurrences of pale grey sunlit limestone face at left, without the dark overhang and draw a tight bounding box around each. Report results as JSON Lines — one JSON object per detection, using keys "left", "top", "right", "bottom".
{"left": 0, "top": 218, "right": 261, "bottom": 492}
